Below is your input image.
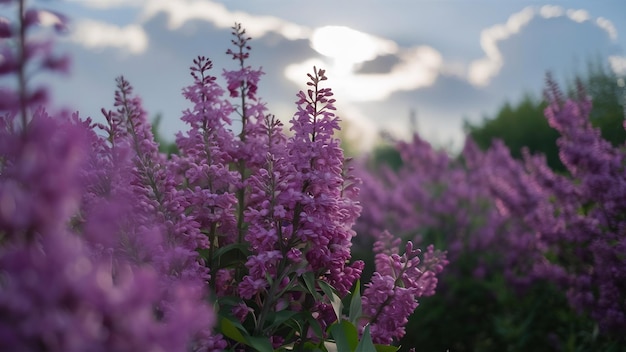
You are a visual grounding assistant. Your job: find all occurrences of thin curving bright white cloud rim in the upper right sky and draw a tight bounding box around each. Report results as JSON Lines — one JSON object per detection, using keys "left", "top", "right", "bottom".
{"left": 467, "top": 5, "right": 617, "bottom": 86}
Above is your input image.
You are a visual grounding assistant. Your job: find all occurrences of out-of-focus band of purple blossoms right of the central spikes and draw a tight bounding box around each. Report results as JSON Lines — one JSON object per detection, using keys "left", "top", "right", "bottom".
{"left": 355, "top": 75, "right": 626, "bottom": 334}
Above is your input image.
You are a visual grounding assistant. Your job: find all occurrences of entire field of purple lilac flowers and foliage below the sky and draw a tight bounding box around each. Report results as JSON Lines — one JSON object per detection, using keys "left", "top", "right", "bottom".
{"left": 0, "top": 0, "right": 626, "bottom": 352}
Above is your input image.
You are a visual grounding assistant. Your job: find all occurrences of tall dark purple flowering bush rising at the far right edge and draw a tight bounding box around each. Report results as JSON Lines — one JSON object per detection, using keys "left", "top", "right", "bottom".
{"left": 486, "top": 78, "right": 626, "bottom": 334}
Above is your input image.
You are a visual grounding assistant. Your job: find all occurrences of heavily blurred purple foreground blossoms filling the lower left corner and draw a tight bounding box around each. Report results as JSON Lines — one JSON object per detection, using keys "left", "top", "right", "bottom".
{"left": 0, "top": 79, "right": 211, "bottom": 351}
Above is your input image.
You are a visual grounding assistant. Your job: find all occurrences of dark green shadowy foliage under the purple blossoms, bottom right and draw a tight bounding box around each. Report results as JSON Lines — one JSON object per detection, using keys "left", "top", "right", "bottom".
{"left": 400, "top": 254, "right": 624, "bottom": 352}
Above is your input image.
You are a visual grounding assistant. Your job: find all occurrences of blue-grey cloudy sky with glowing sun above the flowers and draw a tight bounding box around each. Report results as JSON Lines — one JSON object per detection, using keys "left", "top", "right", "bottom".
{"left": 11, "top": 0, "right": 626, "bottom": 150}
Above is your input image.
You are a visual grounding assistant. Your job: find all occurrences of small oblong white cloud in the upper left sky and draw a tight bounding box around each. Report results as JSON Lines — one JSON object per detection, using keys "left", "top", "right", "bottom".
{"left": 71, "top": 20, "right": 148, "bottom": 54}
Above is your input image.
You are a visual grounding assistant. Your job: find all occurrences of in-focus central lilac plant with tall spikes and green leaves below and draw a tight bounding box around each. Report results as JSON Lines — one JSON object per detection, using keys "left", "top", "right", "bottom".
{"left": 170, "top": 25, "right": 445, "bottom": 350}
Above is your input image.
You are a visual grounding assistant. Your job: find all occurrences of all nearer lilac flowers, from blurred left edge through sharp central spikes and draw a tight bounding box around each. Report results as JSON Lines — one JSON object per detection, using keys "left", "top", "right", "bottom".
{"left": 0, "top": 1, "right": 446, "bottom": 351}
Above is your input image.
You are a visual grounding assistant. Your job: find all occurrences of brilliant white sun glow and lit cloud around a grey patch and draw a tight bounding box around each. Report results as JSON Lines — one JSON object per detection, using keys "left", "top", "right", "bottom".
{"left": 285, "top": 26, "right": 443, "bottom": 102}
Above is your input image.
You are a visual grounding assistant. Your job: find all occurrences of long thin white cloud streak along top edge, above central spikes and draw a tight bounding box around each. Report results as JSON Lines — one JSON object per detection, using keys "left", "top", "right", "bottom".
{"left": 141, "top": 0, "right": 311, "bottom": 40}
